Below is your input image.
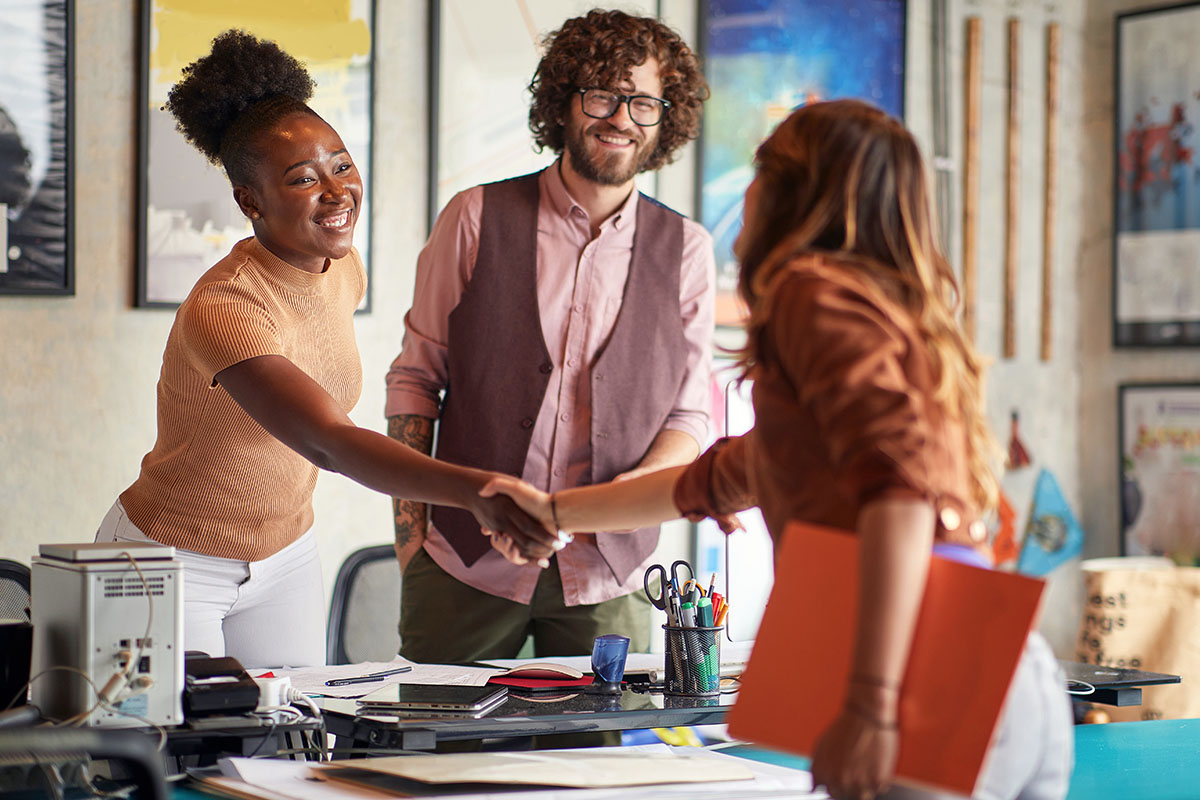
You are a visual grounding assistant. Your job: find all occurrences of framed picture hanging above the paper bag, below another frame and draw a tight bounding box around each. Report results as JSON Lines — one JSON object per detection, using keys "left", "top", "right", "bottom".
{"left": 1117, "top": 384, "right": 1200, "bottom": 565}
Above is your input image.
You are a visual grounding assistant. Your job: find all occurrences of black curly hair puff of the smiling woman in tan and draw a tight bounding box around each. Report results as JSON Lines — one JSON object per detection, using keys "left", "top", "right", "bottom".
{"left": 166, "top": 30, "right": 317, "bottom": 185}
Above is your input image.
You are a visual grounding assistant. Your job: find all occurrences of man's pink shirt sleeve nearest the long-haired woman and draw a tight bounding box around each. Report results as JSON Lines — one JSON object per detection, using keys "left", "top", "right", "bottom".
{"left": 662, "top": 219, "right": 716, "bottom": 446}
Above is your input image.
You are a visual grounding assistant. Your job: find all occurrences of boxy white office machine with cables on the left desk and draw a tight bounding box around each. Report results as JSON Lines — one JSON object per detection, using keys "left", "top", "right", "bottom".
{"left": 30, "top": 542, "right": 184, "bottom": 728}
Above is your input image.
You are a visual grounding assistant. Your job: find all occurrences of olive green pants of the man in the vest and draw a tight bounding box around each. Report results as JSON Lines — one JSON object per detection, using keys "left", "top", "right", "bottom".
{"left": 400, "top": 549, "right": 650, "bottom": 751}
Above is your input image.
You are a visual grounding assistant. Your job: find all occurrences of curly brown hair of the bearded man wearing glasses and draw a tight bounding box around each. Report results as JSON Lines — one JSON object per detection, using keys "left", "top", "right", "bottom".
{"left": 529, "top": 8, "right": 708, "bottom": 170}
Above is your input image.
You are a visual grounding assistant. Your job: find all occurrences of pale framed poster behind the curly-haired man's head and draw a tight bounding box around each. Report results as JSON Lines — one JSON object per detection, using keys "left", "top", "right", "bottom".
{"left": 428, "top": 0, "right": 655, "bottom": 228}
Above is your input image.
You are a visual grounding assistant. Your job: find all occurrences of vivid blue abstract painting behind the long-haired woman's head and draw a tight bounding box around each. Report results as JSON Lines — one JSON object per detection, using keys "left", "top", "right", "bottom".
{"left": 696, "top": 0, "right": 906, "bottom": 325}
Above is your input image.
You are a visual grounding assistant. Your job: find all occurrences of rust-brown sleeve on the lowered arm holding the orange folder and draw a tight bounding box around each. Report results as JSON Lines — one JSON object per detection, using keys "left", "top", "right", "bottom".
{"left": 770, "top": 272, "right": 936, "bottom": 507}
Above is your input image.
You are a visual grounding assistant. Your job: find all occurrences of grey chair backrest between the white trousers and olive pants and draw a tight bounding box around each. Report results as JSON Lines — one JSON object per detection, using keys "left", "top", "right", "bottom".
{"left": 325, "top": 545, "right": 400, "bottom": 664}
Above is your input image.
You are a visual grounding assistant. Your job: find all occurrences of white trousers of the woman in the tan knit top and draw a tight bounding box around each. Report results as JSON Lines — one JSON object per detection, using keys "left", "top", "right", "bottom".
{"left": 96, "top": 500, "right": 325, "bottom": 668}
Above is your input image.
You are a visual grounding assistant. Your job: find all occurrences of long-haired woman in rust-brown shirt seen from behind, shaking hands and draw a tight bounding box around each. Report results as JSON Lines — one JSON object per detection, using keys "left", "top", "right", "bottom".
{"left": 485, "top": 101, "right": 1073, "bottom": 799}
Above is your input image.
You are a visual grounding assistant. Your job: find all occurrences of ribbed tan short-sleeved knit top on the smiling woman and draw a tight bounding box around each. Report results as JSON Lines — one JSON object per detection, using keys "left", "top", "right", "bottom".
{"left": 121, "top": 237, "right": 366, "bottom": 561}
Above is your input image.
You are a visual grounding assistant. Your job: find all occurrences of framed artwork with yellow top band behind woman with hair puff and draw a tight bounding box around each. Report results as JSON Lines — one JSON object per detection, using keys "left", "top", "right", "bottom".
{"left": 137, "top": 0, "right": 374, "bottom": 311}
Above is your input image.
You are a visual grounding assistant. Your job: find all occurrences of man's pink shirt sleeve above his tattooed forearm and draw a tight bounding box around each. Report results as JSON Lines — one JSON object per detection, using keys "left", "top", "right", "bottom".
{"left": 384, "top": 187, "right": 484, "bottom": 420}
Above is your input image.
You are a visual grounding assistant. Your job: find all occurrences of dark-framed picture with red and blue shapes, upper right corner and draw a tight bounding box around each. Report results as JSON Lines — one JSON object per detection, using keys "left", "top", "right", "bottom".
{"left": 1112, "top": 2, "right": 1200, "bottom": 347}
